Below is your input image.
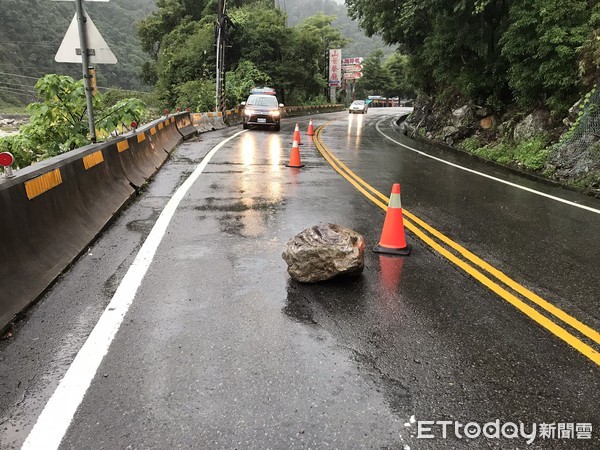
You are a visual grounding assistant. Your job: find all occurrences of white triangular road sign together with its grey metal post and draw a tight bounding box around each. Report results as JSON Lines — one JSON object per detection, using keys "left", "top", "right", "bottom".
{"left": 52, "top": 0, "right": 117, "bottom": 142}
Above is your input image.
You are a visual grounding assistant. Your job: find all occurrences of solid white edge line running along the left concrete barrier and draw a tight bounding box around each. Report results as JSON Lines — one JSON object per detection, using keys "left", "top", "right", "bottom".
{"left": 22, "top": 130, "right": 245, "bottom": 450}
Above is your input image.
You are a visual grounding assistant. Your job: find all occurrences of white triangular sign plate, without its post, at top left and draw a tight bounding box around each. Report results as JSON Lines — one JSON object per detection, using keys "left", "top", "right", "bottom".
{"left": 54, "top": 12, "right": 117, "bottom": 64}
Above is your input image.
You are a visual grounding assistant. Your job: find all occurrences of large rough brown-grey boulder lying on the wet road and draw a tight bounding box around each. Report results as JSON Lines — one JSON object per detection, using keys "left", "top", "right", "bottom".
{"left": 281, "top": 223, "right": 365, "bottom": 283}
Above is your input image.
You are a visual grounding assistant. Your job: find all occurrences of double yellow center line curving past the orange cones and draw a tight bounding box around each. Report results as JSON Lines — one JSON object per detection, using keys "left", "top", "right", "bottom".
{"left": 314, "top": 122, "right": 600, "bottom": 365}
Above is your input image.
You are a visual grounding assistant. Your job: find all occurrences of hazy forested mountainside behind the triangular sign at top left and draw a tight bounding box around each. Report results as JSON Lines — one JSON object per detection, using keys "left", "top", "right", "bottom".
{"left": 0, "top": 0, "right": 154, "bottom": 109}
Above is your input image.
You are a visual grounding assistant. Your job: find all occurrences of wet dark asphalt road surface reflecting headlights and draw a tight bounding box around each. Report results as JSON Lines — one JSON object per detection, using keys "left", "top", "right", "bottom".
{"left": 0, "top": 109, "right": 600, "bottom": 449}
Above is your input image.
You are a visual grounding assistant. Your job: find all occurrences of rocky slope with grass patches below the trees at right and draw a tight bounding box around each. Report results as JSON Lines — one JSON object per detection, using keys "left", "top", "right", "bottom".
{"left": 402, "top": 91, "right": 600, "bottom": 195}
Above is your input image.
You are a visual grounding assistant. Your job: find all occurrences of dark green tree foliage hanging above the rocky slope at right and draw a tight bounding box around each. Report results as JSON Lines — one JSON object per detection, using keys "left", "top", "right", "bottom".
{"left": 346, "top": 0, "right": 600, "bottom": 114}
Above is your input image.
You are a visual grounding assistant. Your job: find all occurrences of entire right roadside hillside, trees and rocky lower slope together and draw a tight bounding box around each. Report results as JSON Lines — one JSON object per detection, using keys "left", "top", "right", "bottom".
{"left": 346, "top": 0, "right": 600, "bottom": 192}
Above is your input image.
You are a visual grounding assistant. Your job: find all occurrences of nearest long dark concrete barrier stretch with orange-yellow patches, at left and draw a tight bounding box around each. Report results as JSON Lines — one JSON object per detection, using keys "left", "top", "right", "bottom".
{"left": 0, "top": 113, "right": 192, "bottom": 329}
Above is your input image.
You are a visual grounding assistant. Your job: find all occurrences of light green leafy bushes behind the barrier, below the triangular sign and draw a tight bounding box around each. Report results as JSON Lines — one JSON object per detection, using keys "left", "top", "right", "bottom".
{"left": 0, "top": 74, "right": 146, "bottom": 167}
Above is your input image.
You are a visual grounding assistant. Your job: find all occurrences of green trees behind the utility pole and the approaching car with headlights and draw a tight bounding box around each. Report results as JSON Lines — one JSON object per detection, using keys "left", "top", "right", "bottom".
{"left": 139, "top": 0, "right": 348, "bottom": 110}
